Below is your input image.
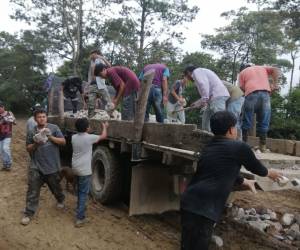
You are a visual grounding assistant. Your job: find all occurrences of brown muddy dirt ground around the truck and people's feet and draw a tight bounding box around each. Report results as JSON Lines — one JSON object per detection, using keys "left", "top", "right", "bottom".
{"left": 0, "top": 119, "right": 300, "bottom": 250}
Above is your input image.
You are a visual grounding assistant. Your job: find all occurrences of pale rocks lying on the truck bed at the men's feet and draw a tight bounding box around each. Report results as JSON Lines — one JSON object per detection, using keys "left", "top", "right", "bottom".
{"left": 65, "top": 109, "right": 121, "bottom": 121}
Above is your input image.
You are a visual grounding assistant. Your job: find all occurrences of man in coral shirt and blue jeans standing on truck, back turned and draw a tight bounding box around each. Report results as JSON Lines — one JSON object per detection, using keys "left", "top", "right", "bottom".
{"left": 239, "top": 64, "right": 279, "bottom": 152}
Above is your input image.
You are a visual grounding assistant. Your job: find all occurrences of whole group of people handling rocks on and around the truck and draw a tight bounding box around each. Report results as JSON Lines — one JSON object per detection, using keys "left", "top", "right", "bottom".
{"left": 0, "top": 48, "right": 281, "bottom": 246}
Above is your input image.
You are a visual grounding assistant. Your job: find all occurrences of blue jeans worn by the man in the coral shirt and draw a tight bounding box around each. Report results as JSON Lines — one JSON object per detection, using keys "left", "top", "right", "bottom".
{"left": 242, "top": 90, "right": 271, "bottom": 135}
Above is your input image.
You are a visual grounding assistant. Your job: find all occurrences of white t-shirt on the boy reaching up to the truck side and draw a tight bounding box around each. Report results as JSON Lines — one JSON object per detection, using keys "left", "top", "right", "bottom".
{"left": 72, "top": 133, "right": 99, "bottom": 176}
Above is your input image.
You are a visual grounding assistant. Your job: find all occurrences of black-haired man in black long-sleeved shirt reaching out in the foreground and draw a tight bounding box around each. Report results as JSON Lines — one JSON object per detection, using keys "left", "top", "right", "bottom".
{"left": 181, "top": 111, "right": 281, "bottom": 250}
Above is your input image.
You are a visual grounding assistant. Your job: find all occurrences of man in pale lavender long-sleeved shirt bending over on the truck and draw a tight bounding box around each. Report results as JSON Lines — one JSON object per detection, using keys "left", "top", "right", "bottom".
{"left": 184, "top": 66, "right": 230, "bottom": 131}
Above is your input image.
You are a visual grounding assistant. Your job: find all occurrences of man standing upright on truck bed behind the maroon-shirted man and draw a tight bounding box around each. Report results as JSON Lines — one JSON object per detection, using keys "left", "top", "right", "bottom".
{"left": 88, "top": 50, "right": 115, "bottom": 118}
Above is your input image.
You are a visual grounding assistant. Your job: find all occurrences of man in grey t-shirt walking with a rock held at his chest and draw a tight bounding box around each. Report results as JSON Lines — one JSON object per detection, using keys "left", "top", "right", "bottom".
{"left": 21, "top": 109, "right": 66, "bottom": 225}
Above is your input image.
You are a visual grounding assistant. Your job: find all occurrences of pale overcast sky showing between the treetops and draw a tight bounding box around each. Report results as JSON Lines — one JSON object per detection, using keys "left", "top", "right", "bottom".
{"left": 0, "top": 0, "right": 300, "bottom": 93}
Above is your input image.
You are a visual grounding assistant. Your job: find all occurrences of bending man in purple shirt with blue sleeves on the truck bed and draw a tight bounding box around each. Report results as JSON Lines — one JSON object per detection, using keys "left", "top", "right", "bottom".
{"left": 139, "top": 63, "right": 170, "bottom": 123}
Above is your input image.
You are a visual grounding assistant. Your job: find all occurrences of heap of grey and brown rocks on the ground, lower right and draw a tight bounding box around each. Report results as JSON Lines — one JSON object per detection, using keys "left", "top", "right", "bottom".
{"left": 228, "top": 205, "right": 300, "bottom": 245}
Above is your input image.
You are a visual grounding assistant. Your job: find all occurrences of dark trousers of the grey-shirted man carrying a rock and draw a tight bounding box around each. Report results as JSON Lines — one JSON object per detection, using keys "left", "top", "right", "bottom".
{"left": 25, "top": 169, "right": 65, "bottom": 217}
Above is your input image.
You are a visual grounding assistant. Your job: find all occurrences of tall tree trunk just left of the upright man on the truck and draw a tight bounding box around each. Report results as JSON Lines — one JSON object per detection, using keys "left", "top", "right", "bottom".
{"left": 73, "top": 0, "right": 83, "bottom": 76}
